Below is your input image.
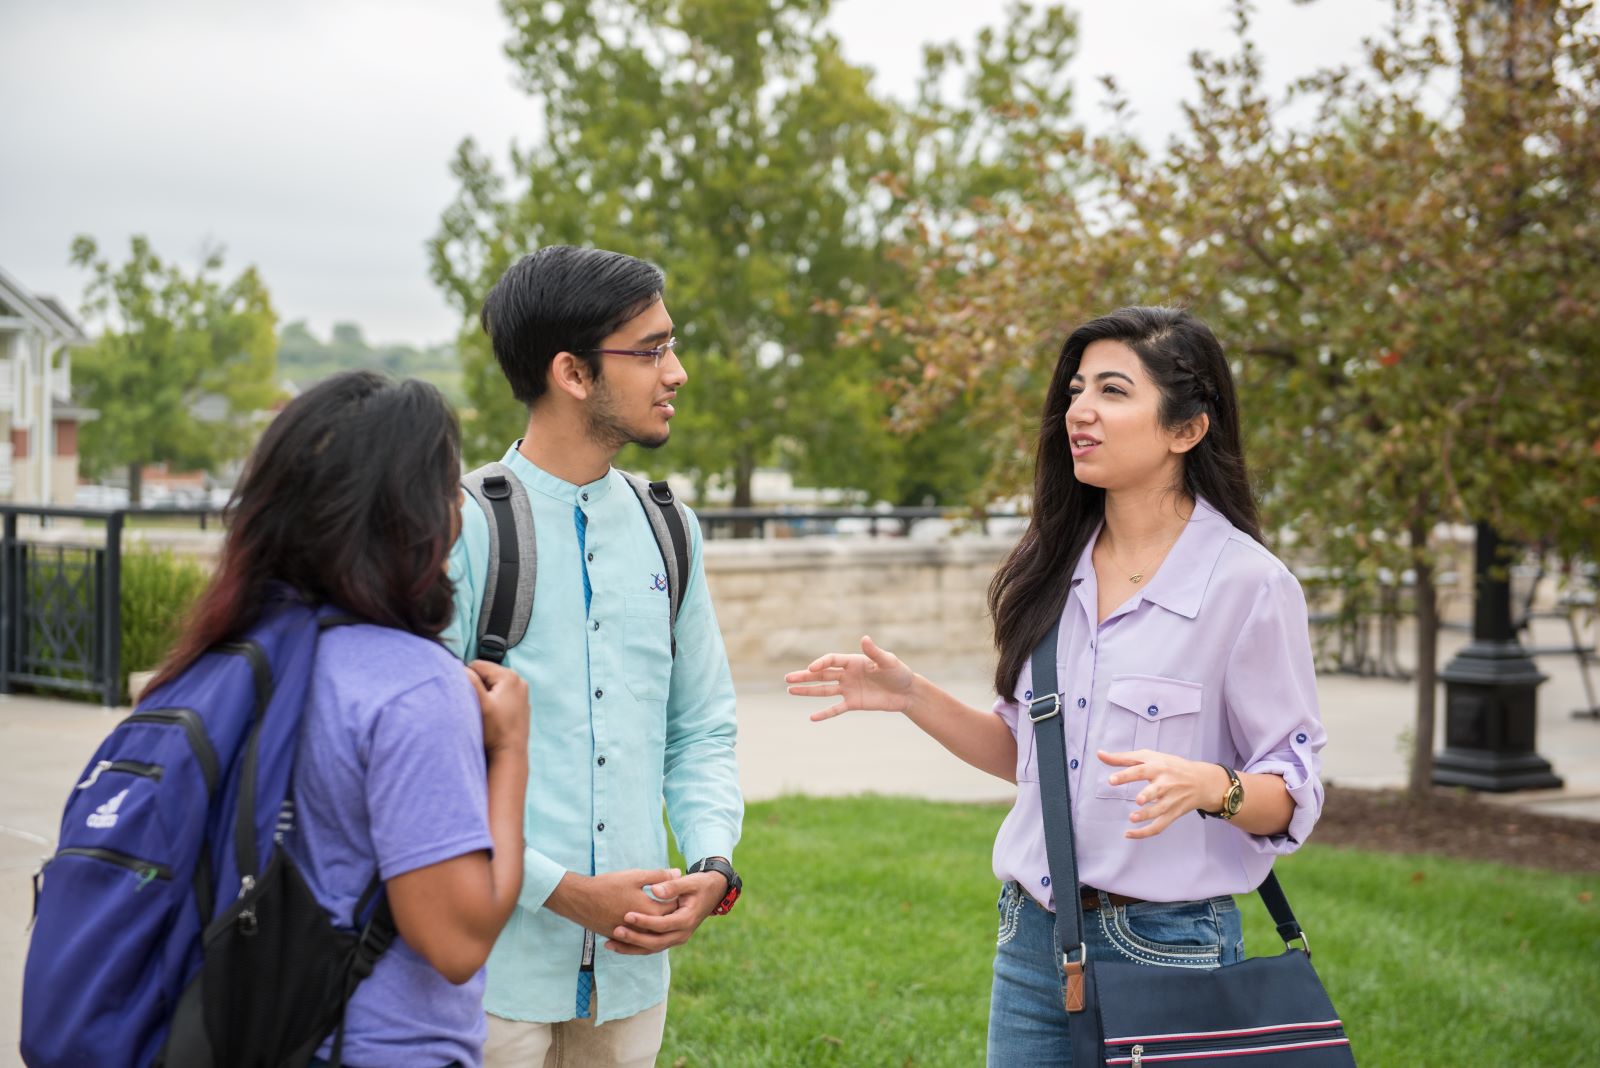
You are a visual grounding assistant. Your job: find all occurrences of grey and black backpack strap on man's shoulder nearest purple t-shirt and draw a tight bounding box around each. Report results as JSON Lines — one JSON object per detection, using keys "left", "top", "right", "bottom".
{"left": 461, "top": 460, "right": 538, "bottom": 664}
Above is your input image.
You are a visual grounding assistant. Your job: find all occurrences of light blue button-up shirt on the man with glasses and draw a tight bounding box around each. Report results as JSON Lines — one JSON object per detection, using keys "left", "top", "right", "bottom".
{"left": 445, "top": 446, "right": 744, "bottom": 1023}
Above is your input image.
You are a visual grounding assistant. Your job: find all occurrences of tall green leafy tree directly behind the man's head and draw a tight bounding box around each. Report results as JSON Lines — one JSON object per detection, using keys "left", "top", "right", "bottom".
{"left": 432, "top": 0, "right": 1072, "bottom": 504}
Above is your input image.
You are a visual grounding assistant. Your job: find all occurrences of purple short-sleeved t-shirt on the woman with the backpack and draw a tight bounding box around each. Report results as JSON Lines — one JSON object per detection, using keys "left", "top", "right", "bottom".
{"left": 288, "top": 625, "right": 493, "bottom": 1068}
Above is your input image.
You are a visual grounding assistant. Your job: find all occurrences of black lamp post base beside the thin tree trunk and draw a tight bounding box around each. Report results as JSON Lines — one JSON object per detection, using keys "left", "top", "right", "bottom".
{"left": 1434, "top": 523, "right": 1562, "bottom": 793}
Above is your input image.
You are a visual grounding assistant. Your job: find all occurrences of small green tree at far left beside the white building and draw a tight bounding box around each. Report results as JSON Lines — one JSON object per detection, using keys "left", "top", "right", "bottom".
{"left": 72, "top": 237, "right": 278, "bottom": 505}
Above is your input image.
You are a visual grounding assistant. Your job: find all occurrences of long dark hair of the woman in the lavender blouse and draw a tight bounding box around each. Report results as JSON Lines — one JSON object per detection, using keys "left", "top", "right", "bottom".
{"left": 989, "top": 307, "right": 1262, "bottom": 695}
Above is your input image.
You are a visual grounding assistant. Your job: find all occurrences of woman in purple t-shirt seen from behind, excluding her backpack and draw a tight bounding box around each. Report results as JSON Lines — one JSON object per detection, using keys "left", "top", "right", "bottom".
{"left": 152, "top": 371, "right": 528, "bottom": 1065}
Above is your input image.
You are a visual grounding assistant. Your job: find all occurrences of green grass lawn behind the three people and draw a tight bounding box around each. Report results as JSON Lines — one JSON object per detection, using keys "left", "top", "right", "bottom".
{"left": 659, "top": 798, "right": 1600, "bottom": 1068}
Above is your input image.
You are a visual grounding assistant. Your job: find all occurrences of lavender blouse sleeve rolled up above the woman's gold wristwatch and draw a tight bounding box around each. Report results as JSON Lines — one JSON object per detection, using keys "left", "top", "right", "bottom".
{"left": 1224, "top": 569, "right": 1328, "bottom": 855}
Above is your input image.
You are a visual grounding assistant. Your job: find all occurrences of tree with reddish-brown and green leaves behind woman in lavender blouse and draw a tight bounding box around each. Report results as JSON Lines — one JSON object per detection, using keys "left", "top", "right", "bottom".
{"left": 880, "top": 0, "right": 1600, "bottom": 790}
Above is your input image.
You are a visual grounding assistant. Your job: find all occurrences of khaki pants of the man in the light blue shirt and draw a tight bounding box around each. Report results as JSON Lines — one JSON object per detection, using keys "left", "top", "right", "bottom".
{"left": 483, "top": 998, "right": 667, "bottom": 1068}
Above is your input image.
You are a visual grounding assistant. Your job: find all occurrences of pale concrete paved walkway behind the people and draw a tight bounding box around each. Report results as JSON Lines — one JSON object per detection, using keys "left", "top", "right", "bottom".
{"left": 0, "top": 624, "right": 1600, "bottom": 1048}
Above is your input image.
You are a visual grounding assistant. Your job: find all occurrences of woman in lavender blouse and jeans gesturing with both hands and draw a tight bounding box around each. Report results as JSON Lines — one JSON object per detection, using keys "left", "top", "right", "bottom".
{"left": 786, "top": 307, "right": 1326, "bottom": 1065}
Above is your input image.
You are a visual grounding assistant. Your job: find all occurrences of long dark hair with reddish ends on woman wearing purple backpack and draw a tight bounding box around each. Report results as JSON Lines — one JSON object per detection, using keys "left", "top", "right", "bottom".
{"left": 152, "top": 371, "right": 461, "bottom": 689}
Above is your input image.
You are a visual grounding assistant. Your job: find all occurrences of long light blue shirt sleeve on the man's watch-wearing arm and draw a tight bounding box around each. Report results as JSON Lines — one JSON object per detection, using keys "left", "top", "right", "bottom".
{"left": 662, "top": 511, "right": 744, "bottom": 863}
